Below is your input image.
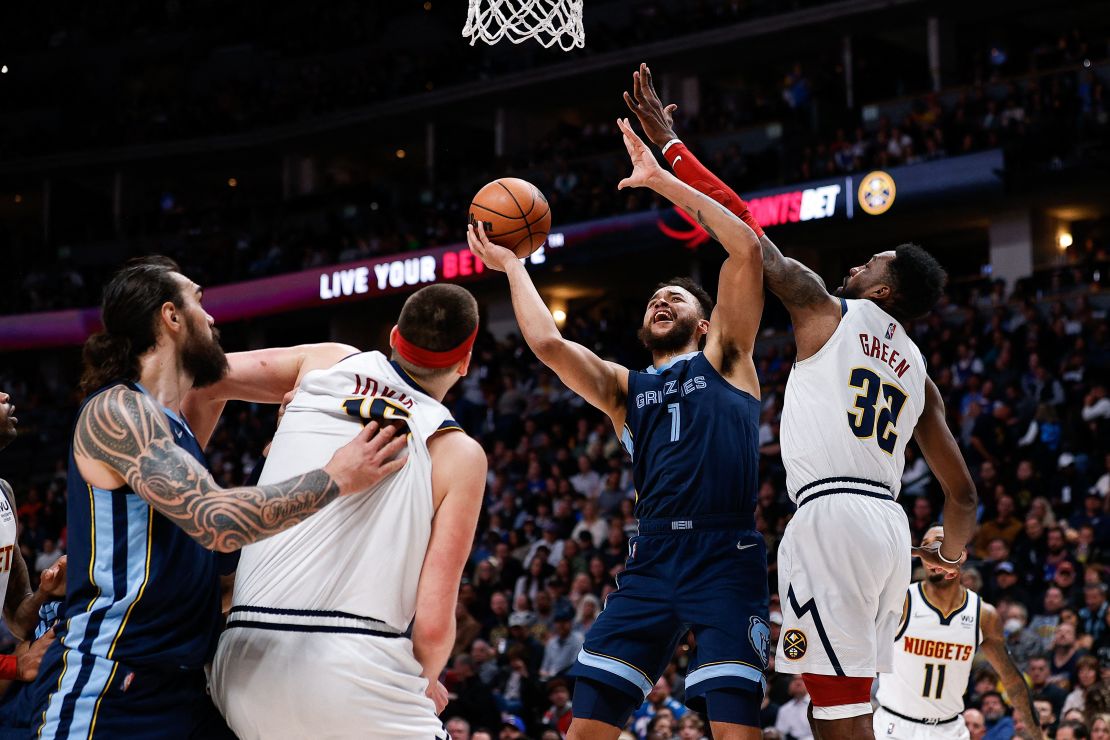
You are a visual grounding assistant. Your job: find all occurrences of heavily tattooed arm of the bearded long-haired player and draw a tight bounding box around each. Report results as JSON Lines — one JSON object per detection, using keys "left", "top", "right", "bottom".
{"left": 73, "top": 386, "right": 405, "bottom": 553}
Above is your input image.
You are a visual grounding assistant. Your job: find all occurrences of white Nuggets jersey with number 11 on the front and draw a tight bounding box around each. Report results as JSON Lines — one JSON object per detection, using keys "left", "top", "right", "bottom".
{"left": 877, "top": 581, "right": 982, "bottom": 719}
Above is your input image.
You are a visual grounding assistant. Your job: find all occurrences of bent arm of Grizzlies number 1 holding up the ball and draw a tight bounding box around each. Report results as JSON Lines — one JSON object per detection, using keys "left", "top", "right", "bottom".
{"left": 466, "top": 224, "right": 628, "bottom": 432}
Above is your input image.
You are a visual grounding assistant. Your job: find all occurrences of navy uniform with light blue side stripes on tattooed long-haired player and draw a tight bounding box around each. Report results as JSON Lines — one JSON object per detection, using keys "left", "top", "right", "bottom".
{"left": 33, "top": 383, "right": 233, "bottom": 738}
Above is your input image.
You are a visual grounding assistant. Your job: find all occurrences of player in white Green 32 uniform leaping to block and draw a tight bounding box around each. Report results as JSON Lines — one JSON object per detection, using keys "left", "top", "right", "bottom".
{"left": 625, "top": 64, "right": 976, "bottom": 740}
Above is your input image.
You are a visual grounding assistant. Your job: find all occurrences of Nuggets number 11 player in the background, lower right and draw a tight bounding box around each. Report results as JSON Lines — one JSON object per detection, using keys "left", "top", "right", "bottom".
{"left": 875, "top": 527, "right": 1045, "bottom": 740}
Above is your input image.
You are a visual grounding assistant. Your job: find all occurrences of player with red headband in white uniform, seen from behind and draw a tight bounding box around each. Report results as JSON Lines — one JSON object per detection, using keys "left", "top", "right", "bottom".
{"left": 184, "top": 284, "right": 486, "bottom": 740}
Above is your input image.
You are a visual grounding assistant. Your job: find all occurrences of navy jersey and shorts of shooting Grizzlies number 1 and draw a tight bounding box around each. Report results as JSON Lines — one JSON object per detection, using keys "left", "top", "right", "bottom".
{"left": 572, "top": 352, "right": 770, "bottom": 718}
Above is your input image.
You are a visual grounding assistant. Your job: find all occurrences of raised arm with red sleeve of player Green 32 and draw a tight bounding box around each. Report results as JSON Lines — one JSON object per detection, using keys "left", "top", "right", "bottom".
{"left": 624, "top": 64, "right": 840, "bottom": 357}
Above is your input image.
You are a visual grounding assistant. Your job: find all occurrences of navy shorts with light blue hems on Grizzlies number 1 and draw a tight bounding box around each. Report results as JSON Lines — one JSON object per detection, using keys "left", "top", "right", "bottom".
{"left": 571, "top": 517, "right": 770, "bottom": 719}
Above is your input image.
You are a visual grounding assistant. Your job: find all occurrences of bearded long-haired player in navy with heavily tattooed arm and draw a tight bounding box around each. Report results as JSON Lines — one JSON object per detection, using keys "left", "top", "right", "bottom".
{"left": 32, "top": 257, "right": 405, "bottom": 739}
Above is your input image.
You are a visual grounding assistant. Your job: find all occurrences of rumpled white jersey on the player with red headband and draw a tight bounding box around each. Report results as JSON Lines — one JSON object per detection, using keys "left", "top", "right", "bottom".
{"left": 233, "top": 352, "right": 457, "bottom": 631}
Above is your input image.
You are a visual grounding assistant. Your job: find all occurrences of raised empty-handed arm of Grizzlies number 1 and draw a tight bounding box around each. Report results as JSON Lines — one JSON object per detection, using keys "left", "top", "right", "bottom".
{"left": 617, "top": 115, "right": 764, "bottom": 397}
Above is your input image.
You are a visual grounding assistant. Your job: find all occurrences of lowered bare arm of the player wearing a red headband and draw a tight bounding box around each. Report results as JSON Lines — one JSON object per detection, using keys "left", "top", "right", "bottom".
{"left": 412, "top": 432, "right": 486, "bottom": 681}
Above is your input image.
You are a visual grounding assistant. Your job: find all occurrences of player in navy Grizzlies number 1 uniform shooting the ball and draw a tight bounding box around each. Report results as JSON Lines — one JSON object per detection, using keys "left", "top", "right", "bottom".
{"left": 467, "top": 121, "right": 770, "bottom": 740}
